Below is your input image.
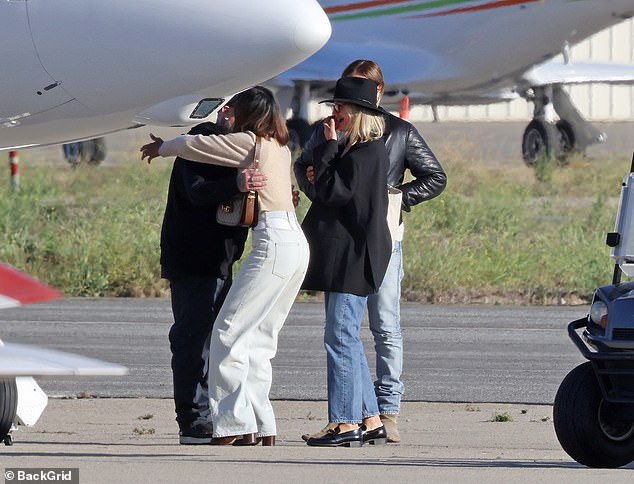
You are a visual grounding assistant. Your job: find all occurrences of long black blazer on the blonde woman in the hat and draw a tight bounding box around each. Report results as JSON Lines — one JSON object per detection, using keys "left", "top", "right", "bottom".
{"left": 302, "top": 140, "right": 392, "bottom": 296}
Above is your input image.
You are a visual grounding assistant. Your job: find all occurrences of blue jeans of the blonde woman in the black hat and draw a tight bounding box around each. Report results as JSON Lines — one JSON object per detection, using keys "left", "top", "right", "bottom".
{"left": 324, "top": 292, "right": 379, "bottom": 423}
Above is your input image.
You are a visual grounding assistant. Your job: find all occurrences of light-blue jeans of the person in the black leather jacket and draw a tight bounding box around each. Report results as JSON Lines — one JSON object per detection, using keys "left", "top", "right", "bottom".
{"left": 368, "top": 241, "right": 404, "bottom": 415}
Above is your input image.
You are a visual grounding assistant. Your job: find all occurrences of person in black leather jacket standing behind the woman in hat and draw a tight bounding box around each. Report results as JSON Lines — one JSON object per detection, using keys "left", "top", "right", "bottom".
{"left": 294, "top": 59, "right": 447, "bottom": 442}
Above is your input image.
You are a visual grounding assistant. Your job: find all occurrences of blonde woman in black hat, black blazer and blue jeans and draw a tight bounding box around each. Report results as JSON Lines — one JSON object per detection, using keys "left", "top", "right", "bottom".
{"left": 302, "top": 77, "right": 392, "bottom": 447}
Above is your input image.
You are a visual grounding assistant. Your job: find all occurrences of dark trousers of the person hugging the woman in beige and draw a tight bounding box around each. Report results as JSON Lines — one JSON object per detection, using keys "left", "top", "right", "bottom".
{"left": 169, "top": 276, "right": 231, "bottom": 428}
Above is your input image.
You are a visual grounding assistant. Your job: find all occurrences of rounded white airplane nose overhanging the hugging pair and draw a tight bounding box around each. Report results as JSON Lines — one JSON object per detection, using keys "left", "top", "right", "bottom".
{"left": 0, "top": 0, "right": 331, "bottom": 146}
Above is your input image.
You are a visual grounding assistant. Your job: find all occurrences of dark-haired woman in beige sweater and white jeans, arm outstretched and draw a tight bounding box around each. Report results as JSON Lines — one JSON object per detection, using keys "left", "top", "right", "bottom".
{"left": 141, "top": 86, "right": 308, "bottom": 445}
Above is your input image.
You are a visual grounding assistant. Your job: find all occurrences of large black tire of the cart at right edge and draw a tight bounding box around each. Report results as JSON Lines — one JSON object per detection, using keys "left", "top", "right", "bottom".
{"left": 553, "top": 361, "right": 634, "bottom": 469}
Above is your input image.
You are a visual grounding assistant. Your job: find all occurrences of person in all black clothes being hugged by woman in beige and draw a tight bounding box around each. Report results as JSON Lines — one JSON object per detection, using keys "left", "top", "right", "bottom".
{"left": 161, "top": 105, "right": 266, "bottom": 444}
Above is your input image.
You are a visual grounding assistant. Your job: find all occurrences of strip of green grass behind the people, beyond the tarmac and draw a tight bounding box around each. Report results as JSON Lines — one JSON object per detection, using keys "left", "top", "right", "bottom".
{"left": 0, "top": 146, "right": 630, "bottom": 304}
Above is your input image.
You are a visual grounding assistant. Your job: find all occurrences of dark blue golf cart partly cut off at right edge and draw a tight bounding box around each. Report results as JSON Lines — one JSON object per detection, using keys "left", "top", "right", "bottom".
{"left": 553, "top": 152, "right": 634, "bottom": 468}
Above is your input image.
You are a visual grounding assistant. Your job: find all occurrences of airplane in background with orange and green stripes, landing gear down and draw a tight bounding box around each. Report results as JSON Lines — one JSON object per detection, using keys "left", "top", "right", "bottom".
{"left": 271, "top": 0, "right": 634, "bottom": 164}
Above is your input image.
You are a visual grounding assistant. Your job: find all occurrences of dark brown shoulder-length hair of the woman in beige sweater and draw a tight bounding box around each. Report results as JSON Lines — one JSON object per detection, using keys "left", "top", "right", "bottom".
{"left": 231, "top": 86, "right": 289, "bottom": 146}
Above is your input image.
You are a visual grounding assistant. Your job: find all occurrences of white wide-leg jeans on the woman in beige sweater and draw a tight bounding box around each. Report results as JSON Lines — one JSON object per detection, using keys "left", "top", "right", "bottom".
{"left": 209, "top": 211, "right": 309, "bottom": 437}
